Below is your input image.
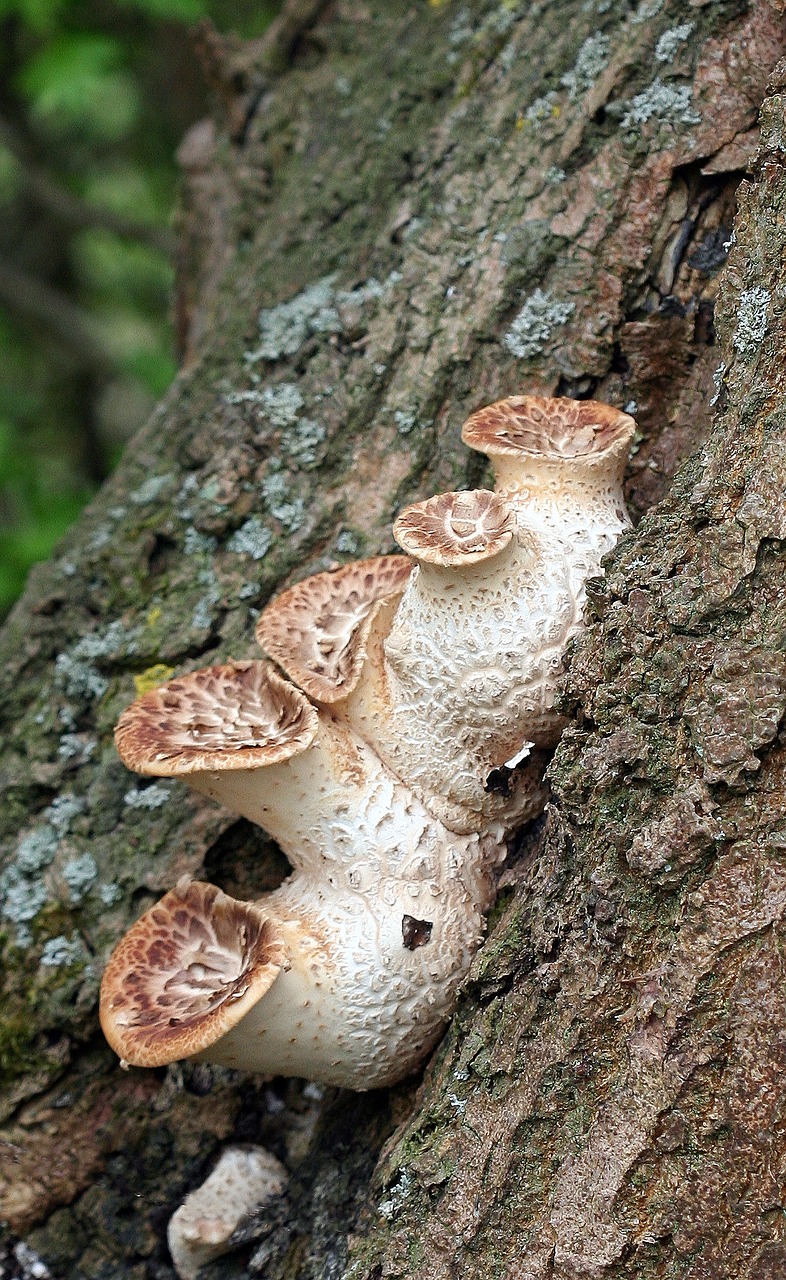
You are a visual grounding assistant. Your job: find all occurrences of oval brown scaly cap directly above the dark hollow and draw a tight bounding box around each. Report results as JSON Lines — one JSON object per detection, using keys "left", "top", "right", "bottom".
{"left": 115, "top": 662, "right": 319, "bottom": 778}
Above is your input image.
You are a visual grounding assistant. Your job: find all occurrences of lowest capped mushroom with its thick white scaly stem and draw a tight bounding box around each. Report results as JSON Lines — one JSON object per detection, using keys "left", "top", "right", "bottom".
{"left": 101, "top": 783, "right": 504, "bottom": 1089}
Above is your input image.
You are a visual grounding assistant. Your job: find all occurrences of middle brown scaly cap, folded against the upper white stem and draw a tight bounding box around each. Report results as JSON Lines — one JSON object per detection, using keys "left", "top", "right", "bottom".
{"left": 256, "top": 556, "right": 413, "bottom": 703}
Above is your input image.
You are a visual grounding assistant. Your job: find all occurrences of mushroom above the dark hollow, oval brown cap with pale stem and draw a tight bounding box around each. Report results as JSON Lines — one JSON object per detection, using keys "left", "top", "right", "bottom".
{"left": 115, "top": 662, "right": 407, "bottom": 868}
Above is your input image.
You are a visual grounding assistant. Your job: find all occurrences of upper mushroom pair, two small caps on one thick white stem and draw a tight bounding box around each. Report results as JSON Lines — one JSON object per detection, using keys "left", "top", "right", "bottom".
{"left": 344, "top": 396, "right": 635, "bottom": 831}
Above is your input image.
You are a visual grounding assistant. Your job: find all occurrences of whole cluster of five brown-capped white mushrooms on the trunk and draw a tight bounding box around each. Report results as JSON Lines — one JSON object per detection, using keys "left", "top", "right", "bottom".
{"left": 101, "top": 396, "right": 635, "bottom": 1089}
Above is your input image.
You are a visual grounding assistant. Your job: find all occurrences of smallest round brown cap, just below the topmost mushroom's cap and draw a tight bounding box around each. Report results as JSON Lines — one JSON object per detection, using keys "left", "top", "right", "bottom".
{"left": 393, "top": 489, "right": 515, "bottom": 566}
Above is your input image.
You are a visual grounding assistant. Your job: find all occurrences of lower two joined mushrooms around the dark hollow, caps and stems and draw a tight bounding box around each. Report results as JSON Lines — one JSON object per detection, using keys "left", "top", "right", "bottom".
{"left": 101, "top": 662, "right": 504, "bottom": 1089}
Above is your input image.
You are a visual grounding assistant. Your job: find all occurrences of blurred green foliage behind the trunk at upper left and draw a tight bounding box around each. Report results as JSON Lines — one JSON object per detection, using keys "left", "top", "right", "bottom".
{"left": 0, "top": 0, "right": 279, "bottom": 614}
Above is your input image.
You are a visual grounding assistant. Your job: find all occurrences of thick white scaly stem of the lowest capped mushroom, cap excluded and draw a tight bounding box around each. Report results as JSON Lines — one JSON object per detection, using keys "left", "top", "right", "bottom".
{"left": 190, "top": 819, "right": 504, "bottom": 1091}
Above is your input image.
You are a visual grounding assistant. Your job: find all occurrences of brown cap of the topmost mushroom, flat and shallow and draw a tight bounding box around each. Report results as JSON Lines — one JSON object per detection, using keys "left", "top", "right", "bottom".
{"left": 461, "top": 396, "right": 636, "bottom": 461}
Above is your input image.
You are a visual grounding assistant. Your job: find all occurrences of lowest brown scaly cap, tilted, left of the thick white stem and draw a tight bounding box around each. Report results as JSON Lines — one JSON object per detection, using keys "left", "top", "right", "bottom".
{"left": 100, "top": 879, "right": 288, "bottom": 1066}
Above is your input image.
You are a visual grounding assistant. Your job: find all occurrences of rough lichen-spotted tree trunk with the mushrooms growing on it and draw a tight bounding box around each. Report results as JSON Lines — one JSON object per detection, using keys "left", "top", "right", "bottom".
{"left": 0, "top": 0, "right": 786, "bottom": 1280}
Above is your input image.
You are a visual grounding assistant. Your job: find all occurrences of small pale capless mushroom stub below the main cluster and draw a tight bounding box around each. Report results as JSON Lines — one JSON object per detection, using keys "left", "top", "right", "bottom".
{"left": 166, "top": 1147, "right": 288, "bottom": 1280}
